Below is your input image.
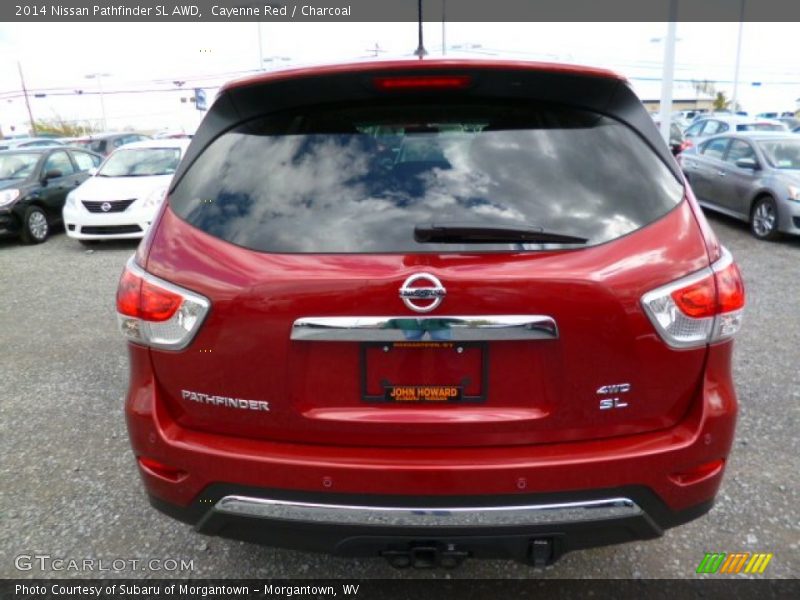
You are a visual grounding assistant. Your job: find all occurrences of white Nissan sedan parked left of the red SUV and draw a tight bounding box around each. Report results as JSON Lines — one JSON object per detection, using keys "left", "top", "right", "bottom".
{"left": 64, "top": 139, "right": 190, "bottom": 243}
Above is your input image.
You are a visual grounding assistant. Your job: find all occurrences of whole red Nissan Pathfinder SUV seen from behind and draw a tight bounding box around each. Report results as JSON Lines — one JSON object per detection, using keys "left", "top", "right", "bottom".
{"left": 117, "top": 59, "right": 744, "bottom": 567}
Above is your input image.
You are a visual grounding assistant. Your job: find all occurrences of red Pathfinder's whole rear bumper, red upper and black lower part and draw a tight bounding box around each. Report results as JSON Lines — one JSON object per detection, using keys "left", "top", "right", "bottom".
{"left": 126, "top": 343, "right": 737, "bottom": 558}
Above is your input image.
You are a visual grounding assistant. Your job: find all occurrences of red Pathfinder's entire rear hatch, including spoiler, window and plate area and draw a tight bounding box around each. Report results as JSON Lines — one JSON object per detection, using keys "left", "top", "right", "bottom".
{"left": 141, "top": 63, "right": 708, "bottom": 447}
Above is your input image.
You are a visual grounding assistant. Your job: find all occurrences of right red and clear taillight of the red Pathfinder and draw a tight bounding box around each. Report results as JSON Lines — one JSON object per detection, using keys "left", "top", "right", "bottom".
{"left": 642, "top": 249, "right": 745, "bottom": 348}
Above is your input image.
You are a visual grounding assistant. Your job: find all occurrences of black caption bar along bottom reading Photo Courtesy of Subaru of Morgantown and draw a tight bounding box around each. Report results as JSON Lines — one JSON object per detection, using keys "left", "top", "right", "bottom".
{"left": 0, "top": 580, "right": 800, "bottom": 600}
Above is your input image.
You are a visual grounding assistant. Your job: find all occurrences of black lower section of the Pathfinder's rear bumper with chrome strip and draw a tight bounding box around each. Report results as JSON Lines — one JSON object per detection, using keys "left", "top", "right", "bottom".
{"left": 150, "top": 484, "right": 712, "bottom": 566}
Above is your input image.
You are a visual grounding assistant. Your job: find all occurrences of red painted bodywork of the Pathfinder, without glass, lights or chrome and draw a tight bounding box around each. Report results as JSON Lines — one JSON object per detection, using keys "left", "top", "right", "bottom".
{"left": 119, "top": 60, "right": 737, "bottom": 564}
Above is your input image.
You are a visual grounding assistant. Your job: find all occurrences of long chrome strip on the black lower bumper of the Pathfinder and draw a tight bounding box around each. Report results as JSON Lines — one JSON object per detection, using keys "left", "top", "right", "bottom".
{"left": 213, "top": 496, "right": 644, "bottom": 527}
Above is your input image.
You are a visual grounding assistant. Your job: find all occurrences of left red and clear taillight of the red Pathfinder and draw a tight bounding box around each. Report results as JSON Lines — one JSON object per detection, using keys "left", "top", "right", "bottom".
{"left": 117, "top": 258, "right": 211, "bottom": 350}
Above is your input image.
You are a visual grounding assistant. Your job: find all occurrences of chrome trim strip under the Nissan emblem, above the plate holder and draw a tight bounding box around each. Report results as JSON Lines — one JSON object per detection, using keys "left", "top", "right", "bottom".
{"left": 291, "top": 315, "right": 558, "bottom": 342}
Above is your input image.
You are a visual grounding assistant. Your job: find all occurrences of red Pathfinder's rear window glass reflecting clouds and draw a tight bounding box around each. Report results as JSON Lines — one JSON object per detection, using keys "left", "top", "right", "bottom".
{"left": 170, "top": 104, "right": 683, "bottom": 253}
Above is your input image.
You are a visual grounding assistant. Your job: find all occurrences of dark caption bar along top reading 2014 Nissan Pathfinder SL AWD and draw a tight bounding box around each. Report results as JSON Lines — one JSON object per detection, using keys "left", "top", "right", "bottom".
{"left": 0, "top": 0, "right": 800, "bottom": 22}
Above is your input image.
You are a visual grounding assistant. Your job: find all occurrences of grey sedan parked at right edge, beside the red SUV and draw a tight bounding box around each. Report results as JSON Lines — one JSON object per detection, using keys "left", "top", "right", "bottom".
{"left": 680, "top": 132, "right": 800, "bottom": 240}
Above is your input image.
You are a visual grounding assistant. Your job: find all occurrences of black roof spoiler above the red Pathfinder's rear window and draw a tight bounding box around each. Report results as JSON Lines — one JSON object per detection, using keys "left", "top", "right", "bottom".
{"left": 172, "top": 60, "right": 683, "bottom": 187}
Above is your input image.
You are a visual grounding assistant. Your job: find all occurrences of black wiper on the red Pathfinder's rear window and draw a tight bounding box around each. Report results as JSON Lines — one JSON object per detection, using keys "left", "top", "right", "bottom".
{"left": 414, "top": 223, "right": 589, "bottom": 244}
